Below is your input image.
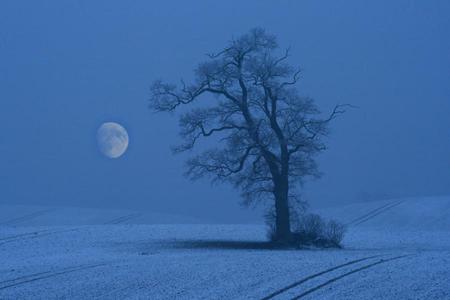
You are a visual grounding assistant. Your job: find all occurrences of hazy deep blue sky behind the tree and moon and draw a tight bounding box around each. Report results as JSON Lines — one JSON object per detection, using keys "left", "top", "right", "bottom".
{"left": 0, "top": 0, "right": 450, "bottom": 222}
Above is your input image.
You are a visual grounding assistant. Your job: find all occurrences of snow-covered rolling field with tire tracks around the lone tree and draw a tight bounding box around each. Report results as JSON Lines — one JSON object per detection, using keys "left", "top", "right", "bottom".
{"left": 0, "top": 197, "right": 450, "bottom": 299}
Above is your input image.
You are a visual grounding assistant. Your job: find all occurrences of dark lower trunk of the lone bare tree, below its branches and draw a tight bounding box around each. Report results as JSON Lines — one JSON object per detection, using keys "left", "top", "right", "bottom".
{"left": 274, "top": 176, "right": 291, "bottom": 243}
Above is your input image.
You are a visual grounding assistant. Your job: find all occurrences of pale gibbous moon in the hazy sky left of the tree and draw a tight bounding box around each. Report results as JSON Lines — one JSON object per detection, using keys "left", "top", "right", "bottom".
{"left": 97, "top": 122, "right": 128, "bottom": 158}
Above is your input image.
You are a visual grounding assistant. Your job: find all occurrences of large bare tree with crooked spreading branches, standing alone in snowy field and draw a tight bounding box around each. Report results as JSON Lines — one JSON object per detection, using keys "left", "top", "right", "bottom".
{"left": 150, "top": 28, "right": 343, "bottom": 241}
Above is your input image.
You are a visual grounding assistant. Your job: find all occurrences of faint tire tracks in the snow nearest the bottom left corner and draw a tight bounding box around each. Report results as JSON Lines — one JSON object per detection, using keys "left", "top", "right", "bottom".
{"left": 0, "top": 263, "right": 108, "bottom": 290}
